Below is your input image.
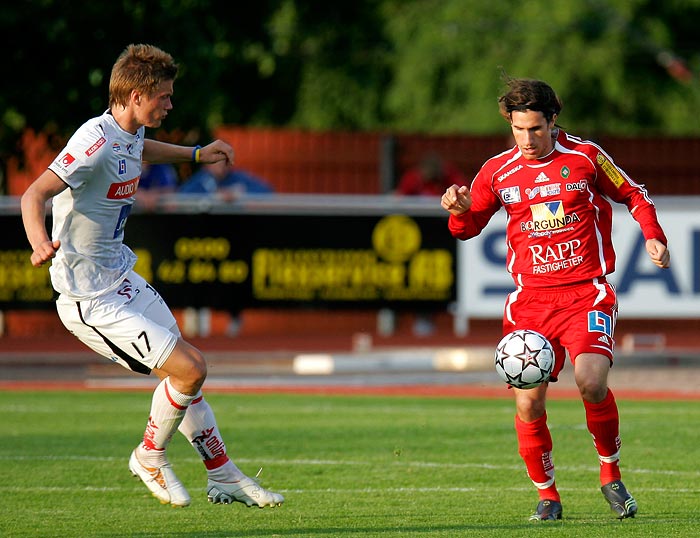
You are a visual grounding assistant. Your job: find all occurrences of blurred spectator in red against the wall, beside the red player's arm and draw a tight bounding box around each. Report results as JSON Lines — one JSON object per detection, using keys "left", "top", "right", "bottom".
{"left": 396, "top": 151, "right": 466, "bottom": 196}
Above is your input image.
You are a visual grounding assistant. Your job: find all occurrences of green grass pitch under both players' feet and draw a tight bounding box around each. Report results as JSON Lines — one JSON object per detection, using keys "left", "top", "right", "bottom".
{"left": 0, "top": 391, "right": 700, "bottom": 538}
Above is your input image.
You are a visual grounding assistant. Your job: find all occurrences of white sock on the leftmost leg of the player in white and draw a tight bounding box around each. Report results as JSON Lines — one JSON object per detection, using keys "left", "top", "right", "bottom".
{"left": 138, "top": 377, "right": 194, "bottom": 467}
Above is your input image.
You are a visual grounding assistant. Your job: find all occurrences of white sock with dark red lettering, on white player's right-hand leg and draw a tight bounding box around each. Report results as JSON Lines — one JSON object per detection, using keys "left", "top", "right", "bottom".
{"left": 178, "top": 392, "right": 245, "bottom": 482}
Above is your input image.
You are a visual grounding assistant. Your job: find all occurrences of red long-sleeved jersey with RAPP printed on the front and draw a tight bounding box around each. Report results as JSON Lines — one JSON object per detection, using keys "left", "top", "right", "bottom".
{"left": 448, "top": 130, "right": 667, "bottom": 287}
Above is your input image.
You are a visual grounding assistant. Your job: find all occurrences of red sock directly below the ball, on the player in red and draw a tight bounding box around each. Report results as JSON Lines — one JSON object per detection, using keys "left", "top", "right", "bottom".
{"left": 515, "top": 413, "right": 561, "bottom": 502}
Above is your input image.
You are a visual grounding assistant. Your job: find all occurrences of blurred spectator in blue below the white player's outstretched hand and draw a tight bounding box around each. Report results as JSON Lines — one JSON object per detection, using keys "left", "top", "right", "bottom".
{"left": 178, "top": 161, "right": 273, "bottom": 196}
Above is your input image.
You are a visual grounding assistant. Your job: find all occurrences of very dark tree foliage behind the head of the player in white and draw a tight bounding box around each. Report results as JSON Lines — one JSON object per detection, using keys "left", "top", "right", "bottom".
{"left": 0, "top": 0, "right": 294, "bottom": 138}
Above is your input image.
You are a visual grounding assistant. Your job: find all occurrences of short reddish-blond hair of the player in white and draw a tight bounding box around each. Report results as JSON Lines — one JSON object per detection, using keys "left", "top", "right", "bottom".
{"left": 109, "top": 44, "right": 178, "bottom": 108}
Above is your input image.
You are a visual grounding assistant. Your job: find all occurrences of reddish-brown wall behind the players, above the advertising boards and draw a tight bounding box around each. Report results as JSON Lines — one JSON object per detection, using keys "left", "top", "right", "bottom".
{"left": 6, "top": 126, "right": 700, "bottom": 196}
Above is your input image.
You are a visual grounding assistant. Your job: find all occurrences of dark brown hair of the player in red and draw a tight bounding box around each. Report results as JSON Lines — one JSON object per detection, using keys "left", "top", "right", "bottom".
{"left": 498, "top": 77, "right": 564, "bottom": 122}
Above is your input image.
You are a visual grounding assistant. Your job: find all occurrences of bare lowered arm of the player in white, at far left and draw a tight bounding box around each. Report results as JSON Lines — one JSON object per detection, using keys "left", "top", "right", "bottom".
{"left": 21, "top": 170, "right": 68, "bottom": 267}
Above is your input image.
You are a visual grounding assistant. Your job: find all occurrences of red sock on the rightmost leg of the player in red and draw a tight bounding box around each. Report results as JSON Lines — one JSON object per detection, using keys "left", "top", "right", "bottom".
{"left": 583, "top": 389, "right": 620, "bottom": 486}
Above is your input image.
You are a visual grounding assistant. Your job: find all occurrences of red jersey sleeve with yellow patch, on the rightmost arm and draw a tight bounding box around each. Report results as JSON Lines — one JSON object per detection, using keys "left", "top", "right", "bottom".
{"left": 595, "top": 149, "right": 668, "bottom": 245}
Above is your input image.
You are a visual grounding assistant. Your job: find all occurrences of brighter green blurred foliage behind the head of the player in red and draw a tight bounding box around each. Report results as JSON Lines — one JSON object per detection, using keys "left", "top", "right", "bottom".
{"left": 374, "top": 0, "right": 700, "bottom": 134}
